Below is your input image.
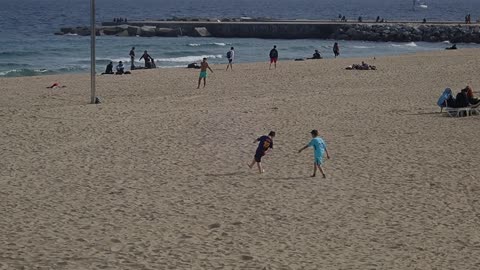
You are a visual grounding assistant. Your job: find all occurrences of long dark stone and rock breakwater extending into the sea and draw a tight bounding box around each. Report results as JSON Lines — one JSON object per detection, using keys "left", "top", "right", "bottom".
{"left": 56, "top": 21, "right": 480, "bottom": 43}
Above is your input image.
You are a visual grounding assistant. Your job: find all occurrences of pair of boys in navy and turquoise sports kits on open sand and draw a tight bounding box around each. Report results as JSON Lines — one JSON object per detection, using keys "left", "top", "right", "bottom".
{"left": 248, "top": 130, "right": 330, "bottom": 178}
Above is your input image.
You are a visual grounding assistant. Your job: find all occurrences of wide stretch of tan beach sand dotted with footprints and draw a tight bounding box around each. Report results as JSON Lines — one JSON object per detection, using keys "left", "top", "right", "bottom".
{"left": 0, "top": 50, "right": 480, "bottom": 270}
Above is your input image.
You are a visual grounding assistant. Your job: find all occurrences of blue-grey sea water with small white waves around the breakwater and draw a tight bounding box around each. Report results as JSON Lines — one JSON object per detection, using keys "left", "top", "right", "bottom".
{"left": 0, "top": 0, "right": 480, "bottom": 77}
